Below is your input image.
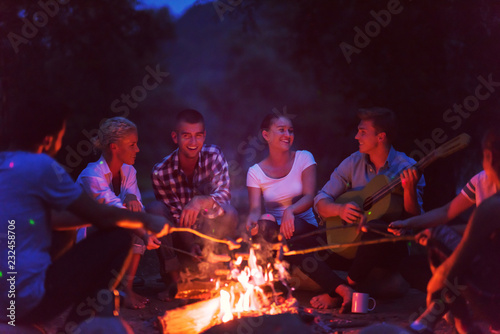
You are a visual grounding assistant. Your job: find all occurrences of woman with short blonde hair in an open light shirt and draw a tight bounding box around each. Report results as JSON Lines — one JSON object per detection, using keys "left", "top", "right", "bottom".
{"left": 77, "top": 117, "right": 160, "bottom": 309}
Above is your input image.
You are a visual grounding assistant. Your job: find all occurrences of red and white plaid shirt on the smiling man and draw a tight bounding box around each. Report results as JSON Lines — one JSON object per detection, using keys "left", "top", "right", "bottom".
{"left": 151, "top": 145, "right": 231, "bottom": 224}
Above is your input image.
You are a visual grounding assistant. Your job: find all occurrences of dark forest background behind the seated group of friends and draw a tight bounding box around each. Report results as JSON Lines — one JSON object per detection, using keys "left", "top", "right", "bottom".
{"left": 0, "top": 0, "right": 500, "bottom": 223}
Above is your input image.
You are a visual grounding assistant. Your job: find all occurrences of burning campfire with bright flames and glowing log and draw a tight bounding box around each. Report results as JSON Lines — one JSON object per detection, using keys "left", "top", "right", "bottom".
{"left": 158, "top": 247, "right": 298, "bottom": 334}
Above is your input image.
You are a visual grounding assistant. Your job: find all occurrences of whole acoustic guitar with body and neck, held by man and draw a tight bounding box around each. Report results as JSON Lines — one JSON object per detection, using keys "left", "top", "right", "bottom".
{"left": 326, "top": 133, "right": 470, "bottom": 259}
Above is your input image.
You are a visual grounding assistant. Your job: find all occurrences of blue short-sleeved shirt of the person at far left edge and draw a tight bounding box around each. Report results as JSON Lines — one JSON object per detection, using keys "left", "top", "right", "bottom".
{"left": 0, "top": 151, "right": 82, "bottom": 321}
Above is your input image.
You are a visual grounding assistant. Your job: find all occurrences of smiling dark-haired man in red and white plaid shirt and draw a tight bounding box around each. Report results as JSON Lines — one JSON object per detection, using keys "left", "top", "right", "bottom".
{"left": 148, "top": 109, "right": 237, "bottom": 300}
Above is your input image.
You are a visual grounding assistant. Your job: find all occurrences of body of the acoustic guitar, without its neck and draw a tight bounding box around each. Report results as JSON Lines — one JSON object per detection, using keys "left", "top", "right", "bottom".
{"left": 326, "top": 175, "right": 403, "bottom": 259}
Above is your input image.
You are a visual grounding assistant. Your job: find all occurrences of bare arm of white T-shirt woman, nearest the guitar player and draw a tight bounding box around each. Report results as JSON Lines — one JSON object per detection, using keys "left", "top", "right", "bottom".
{"left": 280, "top": 164, "right": 316, "bottom": 239}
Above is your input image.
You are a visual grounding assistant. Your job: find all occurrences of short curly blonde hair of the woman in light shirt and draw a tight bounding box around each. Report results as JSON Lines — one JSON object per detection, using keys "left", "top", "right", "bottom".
{"left": 92, "top": 117, "right": 137, "bottom": 152}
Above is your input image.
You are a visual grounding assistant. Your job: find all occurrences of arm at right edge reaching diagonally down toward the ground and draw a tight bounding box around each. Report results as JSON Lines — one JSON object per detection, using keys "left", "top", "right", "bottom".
{"left": 427, "top": 196, "right": 500, "bottom": 295}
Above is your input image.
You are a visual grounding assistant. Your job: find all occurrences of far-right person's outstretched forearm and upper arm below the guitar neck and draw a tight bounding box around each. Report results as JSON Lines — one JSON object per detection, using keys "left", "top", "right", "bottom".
{"left": 389, "top": 193, "right": 474, "bottom": 229}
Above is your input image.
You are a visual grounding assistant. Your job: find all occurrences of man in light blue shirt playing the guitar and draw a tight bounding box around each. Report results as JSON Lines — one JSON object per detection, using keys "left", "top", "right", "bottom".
{"left": 314, "top": 108, "right": 425, "bottom": 307}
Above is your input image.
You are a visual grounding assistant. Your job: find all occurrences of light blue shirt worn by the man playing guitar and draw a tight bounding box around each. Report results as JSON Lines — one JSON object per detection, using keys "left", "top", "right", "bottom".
{"left": 314, "top": 146, "right": 425, "bottom": 217}
